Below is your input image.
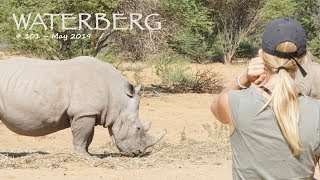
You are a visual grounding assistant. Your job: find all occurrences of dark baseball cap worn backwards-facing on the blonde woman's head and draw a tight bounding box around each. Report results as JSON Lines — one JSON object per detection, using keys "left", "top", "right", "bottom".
{"left": 262, "top": 17, "right": 307, "bottom": 77}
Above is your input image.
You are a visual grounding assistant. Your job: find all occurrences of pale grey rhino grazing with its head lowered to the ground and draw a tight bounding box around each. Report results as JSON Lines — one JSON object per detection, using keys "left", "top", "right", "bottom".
{"left": 0, "top": 56, "right": 166, "bottom": 156}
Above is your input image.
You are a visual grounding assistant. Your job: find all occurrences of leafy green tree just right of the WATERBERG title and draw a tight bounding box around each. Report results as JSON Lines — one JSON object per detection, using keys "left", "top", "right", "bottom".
{"left": 163, "top": 0, "right": 215, "bottom": 62}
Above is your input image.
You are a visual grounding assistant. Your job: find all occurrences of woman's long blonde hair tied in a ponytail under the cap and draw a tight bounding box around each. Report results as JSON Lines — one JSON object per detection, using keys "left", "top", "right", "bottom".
{"left": 262, "top": 42, "right": 301, "bottom": 156}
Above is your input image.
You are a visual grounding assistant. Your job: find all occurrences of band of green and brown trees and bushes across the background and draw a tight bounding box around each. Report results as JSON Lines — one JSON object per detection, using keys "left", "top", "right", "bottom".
{"left": 0, "top": 0, "right": 320, "bottom": 63}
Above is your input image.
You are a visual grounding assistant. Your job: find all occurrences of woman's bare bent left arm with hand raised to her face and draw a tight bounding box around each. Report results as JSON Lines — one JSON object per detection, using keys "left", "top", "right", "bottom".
{"left": 211, "top": 57, "right": 266, "bottom": 125}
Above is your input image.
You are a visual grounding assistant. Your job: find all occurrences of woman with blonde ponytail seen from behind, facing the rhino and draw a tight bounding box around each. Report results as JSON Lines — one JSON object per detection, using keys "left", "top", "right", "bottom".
{"left": 211, "top": 18, "right": 320, "bottom": 179}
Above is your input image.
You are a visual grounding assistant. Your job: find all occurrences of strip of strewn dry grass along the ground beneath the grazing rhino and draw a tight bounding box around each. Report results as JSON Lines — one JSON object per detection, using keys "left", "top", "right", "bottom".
{"left": 0, "top": 124, "right": 230, "bottom": 169}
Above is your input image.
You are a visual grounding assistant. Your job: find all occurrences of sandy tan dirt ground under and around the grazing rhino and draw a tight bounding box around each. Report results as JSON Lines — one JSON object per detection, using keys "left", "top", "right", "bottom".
{"left": 0, "top": 55, "right": 318, "bottom": 180}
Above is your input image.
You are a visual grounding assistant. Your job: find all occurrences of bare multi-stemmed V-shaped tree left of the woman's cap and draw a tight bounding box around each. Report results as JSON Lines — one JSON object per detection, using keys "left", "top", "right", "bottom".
{"left": 206, "top": 0, "right": 262, "bottom": 63}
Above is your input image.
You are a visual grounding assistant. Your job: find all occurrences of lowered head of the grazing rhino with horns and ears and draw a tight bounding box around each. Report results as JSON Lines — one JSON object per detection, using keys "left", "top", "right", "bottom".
{"left": 109, "top": 83, "right": 166, "bottom": 156}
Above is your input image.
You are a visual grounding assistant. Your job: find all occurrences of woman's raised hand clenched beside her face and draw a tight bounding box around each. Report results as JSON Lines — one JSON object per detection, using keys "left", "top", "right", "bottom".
{"left": 244, "top": 57, "right": 267, "bottom": 87}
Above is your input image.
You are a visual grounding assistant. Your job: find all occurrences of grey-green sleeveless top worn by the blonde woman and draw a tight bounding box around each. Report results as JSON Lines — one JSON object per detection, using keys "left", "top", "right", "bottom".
{"left": 228, "top": 87, "right": 320, "bottom": 180}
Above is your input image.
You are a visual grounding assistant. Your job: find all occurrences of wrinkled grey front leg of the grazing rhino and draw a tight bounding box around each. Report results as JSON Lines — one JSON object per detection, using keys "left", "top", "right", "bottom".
{"left": 71, "top": 116, "right": 96, "bottom": 155}
